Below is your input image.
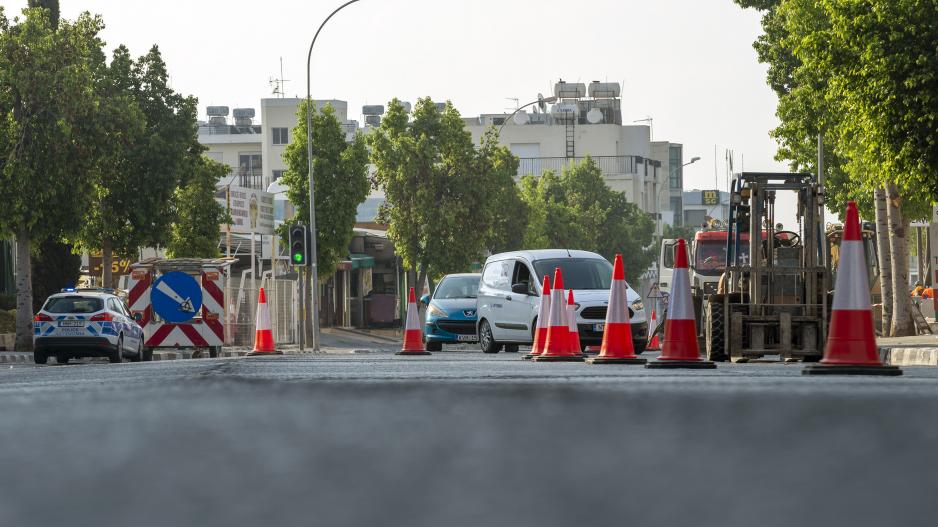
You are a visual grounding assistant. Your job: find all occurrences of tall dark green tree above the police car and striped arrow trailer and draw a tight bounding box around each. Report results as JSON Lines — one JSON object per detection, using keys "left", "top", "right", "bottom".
{"left": 77, "top": 46, "right": 205, "bottom": 284}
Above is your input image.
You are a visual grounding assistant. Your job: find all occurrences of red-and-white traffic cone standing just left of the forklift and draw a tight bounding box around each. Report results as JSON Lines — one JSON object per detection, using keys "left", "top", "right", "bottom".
{"left": 645, "top": 238, "right": 716, "bottom": 368}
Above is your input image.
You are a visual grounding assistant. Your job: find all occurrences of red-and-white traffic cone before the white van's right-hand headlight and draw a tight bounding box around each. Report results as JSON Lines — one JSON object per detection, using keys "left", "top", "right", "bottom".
{"left": 586, "top": 254, "right": 647, "bottom": 364}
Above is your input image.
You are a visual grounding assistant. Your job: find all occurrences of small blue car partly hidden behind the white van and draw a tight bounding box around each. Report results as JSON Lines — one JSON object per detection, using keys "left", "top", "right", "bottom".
{"left": 420, "top": 273, "right": 482, "bottom": 351}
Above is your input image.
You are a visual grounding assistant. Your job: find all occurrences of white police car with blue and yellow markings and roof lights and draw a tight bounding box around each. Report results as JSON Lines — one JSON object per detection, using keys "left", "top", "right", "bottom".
{"left": 33, "top": 289, "right": 146, "bottom": 364}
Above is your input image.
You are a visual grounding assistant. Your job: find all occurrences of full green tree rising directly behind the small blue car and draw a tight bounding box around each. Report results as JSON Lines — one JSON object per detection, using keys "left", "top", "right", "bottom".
{"left": 370, "top": 97, "right": 498, "bottom": 285}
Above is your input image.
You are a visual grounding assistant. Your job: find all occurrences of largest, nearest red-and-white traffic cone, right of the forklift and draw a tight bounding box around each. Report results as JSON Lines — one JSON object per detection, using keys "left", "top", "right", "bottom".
{"left": 801, "top": 201, "right": 902, "bottom": 375}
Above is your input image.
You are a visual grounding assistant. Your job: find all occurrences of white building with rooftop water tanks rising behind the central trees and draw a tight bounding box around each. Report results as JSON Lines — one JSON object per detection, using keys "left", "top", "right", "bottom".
{"left": 464, "top": 81, "right": 683, "bottom": 233}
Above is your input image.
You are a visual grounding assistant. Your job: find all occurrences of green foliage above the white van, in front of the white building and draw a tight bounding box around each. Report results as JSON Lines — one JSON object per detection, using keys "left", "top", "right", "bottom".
{"left": 521, "top": 157, "right": 657, "bottom": 280}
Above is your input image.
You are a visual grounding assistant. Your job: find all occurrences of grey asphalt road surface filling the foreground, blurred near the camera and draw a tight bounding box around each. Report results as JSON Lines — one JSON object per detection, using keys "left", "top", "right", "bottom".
{"left": 0, "top": 352, "right": 938, "bottom": 527}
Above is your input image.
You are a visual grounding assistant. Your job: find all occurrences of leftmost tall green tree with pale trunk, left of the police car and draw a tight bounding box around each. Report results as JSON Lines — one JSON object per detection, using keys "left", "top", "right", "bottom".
{"left": 0, "top": 9, "right": 103, "bottom": 350}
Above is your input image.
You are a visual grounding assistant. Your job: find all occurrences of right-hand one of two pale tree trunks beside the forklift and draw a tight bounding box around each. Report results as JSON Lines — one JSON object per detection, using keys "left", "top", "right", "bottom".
{"left": 886, "top": 183, "right": 915, "bottom": 337}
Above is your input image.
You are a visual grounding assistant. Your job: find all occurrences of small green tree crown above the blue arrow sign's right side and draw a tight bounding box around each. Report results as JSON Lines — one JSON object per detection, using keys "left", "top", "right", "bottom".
{"left": 166, "top": 156, "right": 230, "bottom": 258}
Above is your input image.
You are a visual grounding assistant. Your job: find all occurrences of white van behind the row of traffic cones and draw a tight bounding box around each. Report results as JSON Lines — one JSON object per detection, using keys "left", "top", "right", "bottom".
{"left": 476, "top": 249, "right": 648, "bottom": 353}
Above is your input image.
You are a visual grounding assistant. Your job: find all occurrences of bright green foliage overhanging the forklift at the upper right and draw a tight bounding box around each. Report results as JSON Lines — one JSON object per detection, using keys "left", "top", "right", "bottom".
{"left": 737, "top": 0, "right": 938, "bottom": 219}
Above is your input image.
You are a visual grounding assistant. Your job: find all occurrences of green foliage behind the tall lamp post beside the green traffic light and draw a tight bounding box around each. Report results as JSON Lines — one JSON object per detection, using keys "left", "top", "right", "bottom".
{"left": 281, "top": 100, "right": 370, "bottom": 280}
